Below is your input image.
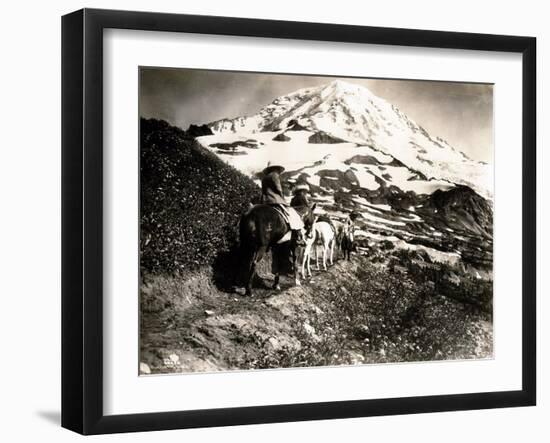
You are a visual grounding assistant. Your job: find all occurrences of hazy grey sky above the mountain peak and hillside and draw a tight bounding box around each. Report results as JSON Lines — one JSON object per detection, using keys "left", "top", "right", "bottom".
{"left": 140, "top": 67, "right": 493, "bottom": 163}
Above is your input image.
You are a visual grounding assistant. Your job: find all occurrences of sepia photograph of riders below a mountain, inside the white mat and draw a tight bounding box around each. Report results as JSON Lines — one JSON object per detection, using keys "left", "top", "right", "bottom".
{"left": 139, "top": 67, "right": 494, "bottom": 375}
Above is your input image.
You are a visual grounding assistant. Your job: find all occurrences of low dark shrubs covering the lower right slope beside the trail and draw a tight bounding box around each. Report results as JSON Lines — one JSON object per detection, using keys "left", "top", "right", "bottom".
{"left": 322, "top": 267, "right": 491, "bottom": 361}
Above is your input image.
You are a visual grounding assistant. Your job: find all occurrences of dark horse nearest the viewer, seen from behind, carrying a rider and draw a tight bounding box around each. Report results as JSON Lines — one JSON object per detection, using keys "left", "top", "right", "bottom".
{"left": 239, "top": 205, "right": 315, "bottom": 295}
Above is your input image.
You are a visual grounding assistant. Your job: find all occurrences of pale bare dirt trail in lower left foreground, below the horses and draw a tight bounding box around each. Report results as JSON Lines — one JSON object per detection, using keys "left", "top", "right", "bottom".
{"left": 141, "top": 261, "right": 357, "bottom": 373}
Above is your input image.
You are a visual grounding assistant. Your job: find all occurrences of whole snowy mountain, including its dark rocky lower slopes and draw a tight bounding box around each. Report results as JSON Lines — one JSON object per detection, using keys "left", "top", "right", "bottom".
{"left": 195, "top": 81, "right": 493, "bottom": 267}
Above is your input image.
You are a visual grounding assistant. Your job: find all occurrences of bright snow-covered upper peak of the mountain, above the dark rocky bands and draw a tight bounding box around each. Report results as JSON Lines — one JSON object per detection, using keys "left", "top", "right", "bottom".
{"left": 209, "top": 80, "right": 493, "bottom": 198}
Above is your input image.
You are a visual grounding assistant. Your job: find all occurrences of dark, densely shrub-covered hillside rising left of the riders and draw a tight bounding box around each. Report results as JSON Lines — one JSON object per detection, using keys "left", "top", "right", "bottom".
{"left": 140, "top": 119, "right": 259, "bottom": 274}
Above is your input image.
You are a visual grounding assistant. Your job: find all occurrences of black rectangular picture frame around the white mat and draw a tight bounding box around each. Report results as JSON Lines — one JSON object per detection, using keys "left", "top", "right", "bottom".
{"left": 62, "top": 9, "right": 536, "bottom": 434}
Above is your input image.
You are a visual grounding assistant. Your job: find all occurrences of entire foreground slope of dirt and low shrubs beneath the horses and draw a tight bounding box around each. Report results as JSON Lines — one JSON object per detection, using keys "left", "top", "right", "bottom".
{"left": 141, "top": 257, "right": 492, "bottom": 373}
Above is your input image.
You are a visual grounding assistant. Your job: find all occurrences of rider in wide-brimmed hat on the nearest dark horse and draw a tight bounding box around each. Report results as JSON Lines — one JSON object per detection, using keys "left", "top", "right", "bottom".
{"left": 262, "top": 163, "right": 304, "bottom": 239}
